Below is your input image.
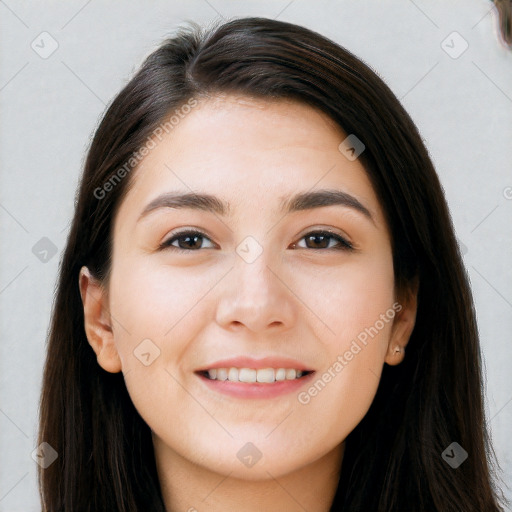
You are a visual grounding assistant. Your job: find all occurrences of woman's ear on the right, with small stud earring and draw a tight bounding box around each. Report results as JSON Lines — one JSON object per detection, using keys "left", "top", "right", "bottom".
{"left": 384, "top": 276, "right": 419, "bottom": 366}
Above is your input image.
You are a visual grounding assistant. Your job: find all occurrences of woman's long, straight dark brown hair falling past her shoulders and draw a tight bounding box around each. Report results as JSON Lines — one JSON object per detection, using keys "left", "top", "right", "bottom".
{"left": 39, "top": 18, "right": 508, "bottom": 512}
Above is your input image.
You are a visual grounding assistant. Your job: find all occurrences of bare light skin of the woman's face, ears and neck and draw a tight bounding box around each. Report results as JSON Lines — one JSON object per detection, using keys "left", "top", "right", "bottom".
{"left": 79, "top": 95, "right": 417, "bottom": 512}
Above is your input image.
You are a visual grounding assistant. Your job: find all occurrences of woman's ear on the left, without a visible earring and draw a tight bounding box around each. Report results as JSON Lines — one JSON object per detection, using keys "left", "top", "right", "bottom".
{"left": 78, "top": 267, "right": 122, "bottom": 373}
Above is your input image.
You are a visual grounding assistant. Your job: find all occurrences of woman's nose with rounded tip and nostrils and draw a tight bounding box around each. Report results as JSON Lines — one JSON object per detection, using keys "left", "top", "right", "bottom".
{"left": 216, "top": 252, "right": 300, "bottom": 333}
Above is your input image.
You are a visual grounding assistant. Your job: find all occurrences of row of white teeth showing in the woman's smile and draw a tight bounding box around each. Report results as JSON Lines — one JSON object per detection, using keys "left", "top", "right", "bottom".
{"left": 196, "top": 367, "right": 314, "bottom": 384}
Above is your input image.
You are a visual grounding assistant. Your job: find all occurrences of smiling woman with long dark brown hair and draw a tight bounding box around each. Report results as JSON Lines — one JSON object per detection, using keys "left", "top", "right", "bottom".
{"left": 39, "top": 18, "right": 508, "bottom": 512}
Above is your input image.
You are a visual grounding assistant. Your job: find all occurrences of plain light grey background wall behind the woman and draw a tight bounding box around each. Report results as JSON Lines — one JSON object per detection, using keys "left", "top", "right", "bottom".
{"left": 0, "top": 0, "right": 512, "bottom": 512}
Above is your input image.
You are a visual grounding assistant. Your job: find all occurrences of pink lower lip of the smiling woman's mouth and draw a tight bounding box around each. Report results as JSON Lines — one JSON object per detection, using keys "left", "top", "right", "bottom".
{"left": 196, "top": 372, "right": 315, "bottom": 398}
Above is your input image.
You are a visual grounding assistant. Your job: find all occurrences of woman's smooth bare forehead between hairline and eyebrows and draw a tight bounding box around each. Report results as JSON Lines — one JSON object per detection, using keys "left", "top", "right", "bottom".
{"left": 115, "top": 95, "right": 380, "bottom": 228}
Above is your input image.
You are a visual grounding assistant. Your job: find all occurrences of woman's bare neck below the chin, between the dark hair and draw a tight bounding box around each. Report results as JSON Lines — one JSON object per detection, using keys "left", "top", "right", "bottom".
{"left": 153, "top": 437, "right": 345, "bottom": 512}
